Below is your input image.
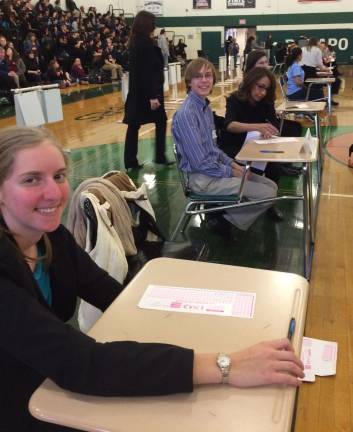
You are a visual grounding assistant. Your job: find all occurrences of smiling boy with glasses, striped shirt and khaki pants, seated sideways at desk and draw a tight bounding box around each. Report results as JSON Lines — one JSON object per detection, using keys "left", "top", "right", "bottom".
{"left": 172, "top": 58, "right": 277, "bottom": 231}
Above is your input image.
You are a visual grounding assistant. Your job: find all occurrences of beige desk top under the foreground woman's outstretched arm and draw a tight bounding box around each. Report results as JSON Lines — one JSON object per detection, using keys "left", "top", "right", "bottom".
{"left": 30, "top": 258, "right": 308, "bottom": 432}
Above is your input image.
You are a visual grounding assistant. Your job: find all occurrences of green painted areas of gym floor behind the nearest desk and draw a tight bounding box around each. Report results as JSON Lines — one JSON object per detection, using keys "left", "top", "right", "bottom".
{"left": 69, "top": 130, "right": 330, "bottom": 275}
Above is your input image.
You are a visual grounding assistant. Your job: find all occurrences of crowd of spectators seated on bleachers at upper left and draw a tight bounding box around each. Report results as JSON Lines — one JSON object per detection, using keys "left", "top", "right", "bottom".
{"left": 0, "top": 0, "right": 130, "bottom": 101}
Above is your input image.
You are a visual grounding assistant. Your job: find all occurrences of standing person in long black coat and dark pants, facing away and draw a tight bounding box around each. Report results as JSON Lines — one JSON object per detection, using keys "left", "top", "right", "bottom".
{"left": 123, "top": 11, "right": 171, "bottom": 169}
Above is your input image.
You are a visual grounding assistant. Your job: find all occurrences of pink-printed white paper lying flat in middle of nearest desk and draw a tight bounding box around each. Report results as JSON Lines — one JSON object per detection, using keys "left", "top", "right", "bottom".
{"left": 138, "top": 285, "right": 256, "bottom": 318}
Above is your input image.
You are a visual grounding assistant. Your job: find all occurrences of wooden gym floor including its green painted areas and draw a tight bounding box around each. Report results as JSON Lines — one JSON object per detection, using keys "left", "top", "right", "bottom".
{"left": 0, "top": 66, "right": 353, "bottom": 432}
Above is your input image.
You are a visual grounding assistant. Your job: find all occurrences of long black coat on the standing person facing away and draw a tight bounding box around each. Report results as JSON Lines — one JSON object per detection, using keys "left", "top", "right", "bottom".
{"left": 123, "top": 37, "right": 167, "bottom": 125}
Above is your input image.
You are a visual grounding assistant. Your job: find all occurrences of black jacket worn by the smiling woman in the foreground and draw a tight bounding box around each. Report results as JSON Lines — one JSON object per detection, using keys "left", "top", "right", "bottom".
{"left": 0, "top": 226, "right": 193, "bottom": 432}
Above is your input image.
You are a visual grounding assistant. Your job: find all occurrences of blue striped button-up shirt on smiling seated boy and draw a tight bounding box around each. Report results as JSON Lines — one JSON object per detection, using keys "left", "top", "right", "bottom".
{"left": 172, "top": 91, "right": 233, "bottom": 177}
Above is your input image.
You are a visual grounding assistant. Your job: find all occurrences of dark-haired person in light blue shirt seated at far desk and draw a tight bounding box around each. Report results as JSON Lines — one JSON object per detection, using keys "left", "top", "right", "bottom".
{"left": 286, "top": 47, "right": 324, "bottom": 100}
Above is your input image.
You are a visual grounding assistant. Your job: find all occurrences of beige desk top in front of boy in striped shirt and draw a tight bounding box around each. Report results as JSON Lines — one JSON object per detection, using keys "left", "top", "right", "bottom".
{"left": 236, "top": 137, "right": 319, "bottom": 163}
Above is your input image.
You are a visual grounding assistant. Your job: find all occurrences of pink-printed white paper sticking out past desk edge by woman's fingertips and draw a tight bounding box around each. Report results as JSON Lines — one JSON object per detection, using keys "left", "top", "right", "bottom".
{"left": 300, "top": 337, "right": 338, "bottom": 382}
